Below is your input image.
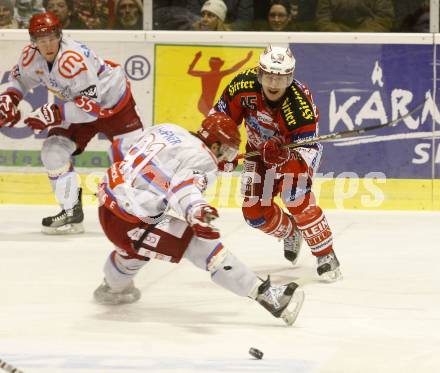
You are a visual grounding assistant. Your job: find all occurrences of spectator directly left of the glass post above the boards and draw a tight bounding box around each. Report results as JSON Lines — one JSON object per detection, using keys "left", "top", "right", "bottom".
{"left": 114, "top": 0, "right": 144, "bottom": 30}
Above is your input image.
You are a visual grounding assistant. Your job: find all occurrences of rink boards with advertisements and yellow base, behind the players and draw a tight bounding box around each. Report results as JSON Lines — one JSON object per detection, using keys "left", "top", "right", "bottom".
{"left": 0, "top": 31, "right": 440, "bottom": 210}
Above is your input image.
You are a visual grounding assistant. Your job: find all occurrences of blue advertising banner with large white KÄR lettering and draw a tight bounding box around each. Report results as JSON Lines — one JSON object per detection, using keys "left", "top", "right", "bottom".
{"left": 291, "top": 44, "right": 440, "bottom": 179}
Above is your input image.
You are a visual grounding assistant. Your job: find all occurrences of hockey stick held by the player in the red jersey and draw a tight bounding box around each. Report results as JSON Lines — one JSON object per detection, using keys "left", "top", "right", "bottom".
{"left": 237, "top": 99, "right": 426, "bottom": 159}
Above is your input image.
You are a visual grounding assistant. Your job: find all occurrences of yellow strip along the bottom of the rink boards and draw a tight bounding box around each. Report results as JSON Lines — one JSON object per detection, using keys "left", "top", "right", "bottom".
{"left": 0, "top": 170, "right": 440, "bottom": 210}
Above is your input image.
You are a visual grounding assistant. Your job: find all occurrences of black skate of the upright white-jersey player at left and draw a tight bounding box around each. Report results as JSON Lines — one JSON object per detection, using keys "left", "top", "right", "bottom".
{"left": 41, "top": 188, "right": 84, "bottom": 235}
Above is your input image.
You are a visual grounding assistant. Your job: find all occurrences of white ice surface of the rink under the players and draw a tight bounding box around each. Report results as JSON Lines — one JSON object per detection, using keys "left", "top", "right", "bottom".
{"left": 0, "top": 205, "right": 440, "bottom": 373}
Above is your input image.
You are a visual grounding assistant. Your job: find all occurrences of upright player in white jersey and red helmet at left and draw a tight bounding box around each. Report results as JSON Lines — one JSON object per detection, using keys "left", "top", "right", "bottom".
{"left": 0, "top": 12, "right": 143, "bottom": 234}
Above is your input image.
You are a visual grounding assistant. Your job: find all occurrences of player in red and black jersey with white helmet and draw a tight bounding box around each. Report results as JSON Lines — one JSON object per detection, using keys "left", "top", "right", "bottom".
{"left": 211, "top": 46, "right": 342, "bottom": 281}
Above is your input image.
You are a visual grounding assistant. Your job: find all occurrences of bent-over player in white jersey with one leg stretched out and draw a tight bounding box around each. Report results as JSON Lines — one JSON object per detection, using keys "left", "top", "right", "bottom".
{"left": 94, "top": 113, "right": 304, "bottom": 325}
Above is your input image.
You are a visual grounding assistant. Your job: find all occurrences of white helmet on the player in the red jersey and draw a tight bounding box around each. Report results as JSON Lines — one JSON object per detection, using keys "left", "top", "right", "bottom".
{"left": 258, "top": 45, "right": 296, "bottom": 89}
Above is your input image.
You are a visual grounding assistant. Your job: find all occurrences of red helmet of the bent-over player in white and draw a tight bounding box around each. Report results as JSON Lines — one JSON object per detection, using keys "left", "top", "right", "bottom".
{"left": 197, "top": 112, "right": 240, "bottom": 162}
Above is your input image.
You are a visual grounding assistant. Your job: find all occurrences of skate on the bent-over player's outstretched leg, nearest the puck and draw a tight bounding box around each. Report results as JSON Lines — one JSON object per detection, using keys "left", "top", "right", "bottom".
{"left": 256, "top": 276, "right": 304, "bottom": 325}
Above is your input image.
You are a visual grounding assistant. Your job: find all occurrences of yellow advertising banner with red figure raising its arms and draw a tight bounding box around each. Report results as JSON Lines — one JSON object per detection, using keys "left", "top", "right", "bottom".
{"left": 153, "top": 44, "right": 263, "bottom": 144}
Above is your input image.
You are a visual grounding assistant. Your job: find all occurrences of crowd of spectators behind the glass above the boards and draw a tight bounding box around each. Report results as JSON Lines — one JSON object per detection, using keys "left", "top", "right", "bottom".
{"left": 0, "top": 0, "right": 429, "bottom": 32}
